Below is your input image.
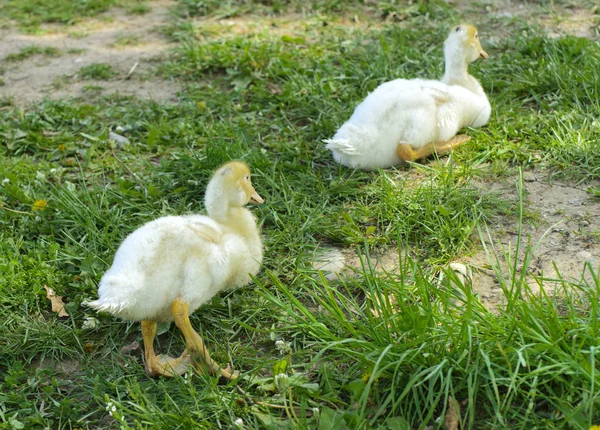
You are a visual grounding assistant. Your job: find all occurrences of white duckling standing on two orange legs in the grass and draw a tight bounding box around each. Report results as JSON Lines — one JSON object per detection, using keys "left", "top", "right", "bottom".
{"left": 87, "top": 161, "right": 263, "bottom": 379}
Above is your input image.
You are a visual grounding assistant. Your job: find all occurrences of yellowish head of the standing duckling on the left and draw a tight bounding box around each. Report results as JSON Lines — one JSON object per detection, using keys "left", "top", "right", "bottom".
{"left": 204, "top": 161, "right": 264, "bottom": 218}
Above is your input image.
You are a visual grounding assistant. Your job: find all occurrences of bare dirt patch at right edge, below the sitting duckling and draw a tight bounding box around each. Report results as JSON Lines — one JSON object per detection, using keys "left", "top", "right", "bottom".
{"left": 459, "top": 172, "right": 600, "bottom": 308}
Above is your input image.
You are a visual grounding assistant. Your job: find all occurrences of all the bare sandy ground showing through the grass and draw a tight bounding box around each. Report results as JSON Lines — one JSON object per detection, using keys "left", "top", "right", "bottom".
{"left": 0, "top": 1, "right": 600, "bottom": 312}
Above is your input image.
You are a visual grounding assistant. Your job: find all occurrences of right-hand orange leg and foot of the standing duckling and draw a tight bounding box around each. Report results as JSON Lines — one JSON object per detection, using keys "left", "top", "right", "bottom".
{"left": 171, "top": 299, "right": 239, "bottom": 379}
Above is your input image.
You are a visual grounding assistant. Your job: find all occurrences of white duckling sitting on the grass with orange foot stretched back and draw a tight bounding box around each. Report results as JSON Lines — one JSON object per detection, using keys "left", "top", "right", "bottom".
{"left": 324, "top": 24, "right": 491, "bottom": 170}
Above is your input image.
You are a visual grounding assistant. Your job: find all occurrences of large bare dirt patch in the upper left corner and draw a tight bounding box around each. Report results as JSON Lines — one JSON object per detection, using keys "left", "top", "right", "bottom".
{"left": 0, "top": 0, "right": 180, "bottom": 105}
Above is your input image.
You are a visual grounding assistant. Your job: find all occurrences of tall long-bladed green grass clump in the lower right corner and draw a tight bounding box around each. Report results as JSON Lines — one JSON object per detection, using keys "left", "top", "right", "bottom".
{"left": 264, "top": 240, "right": 599, "bottom": 428}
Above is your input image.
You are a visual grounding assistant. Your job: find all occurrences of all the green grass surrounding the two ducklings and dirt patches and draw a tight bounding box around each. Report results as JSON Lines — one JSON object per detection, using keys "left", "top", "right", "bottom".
{"left": 0, "top": 1, "right": 600, "bottom": 430}
